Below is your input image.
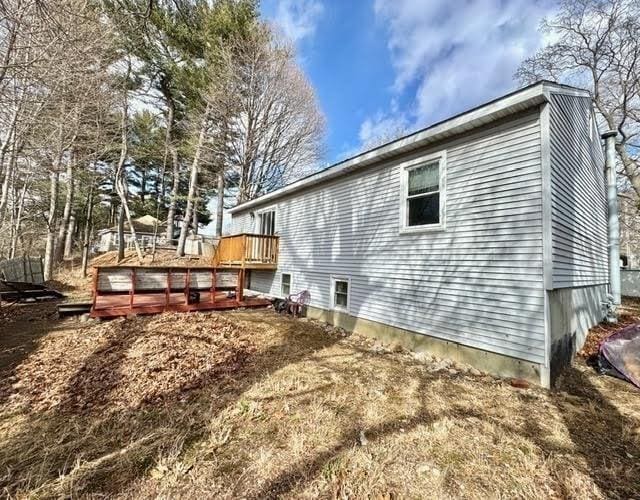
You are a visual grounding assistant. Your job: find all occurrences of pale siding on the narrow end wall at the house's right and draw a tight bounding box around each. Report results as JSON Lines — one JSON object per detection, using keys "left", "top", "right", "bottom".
{"left": 550, "top": 94, "right": 608, "bottom": 288}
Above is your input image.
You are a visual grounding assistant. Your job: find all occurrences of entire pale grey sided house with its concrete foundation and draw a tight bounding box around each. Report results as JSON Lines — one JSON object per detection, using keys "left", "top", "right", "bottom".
{"left": 232, "top": 82, "right": 608, "bottom": 386}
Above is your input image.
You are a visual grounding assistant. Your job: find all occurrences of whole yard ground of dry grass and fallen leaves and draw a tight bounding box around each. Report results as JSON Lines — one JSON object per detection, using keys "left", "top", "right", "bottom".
{"left": 0, "top": 288, "right": 640, "bottom": 498}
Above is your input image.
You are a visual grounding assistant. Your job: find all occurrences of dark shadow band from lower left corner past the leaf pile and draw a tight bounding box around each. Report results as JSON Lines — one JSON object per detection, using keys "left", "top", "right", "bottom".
{"left": 0, "top": 313, "right": 339, "bottom": 497}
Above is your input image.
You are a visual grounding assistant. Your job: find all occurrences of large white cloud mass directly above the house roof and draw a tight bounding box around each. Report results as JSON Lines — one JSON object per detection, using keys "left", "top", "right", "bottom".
{"left": 374, "top": 0, "right": 552, "bottom": 125}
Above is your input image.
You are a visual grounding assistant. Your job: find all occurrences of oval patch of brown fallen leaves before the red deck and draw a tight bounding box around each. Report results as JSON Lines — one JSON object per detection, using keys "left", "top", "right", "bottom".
{"left": 4, "top": 313, "right": 255, "bottom": 413}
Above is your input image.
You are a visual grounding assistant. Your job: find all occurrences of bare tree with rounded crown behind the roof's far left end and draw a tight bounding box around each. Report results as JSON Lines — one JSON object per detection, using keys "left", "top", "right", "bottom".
{"left": 228, "top": 27, "right": 324, "bottom": 202}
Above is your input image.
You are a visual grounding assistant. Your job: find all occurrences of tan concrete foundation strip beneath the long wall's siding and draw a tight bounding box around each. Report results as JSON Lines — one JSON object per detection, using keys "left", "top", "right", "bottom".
{"left": 307, "top": 306, "right": 545, "bottom": 385}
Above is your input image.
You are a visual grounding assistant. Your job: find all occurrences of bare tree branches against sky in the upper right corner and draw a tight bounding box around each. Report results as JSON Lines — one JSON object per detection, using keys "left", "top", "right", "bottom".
{"left": 516, "top": 0, "right": 640, "bottom": 194}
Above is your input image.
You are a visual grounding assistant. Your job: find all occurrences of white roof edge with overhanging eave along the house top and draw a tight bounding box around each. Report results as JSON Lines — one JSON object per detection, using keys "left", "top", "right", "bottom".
{"left": 229, "top": 80, "right": 591, "bottom": 214}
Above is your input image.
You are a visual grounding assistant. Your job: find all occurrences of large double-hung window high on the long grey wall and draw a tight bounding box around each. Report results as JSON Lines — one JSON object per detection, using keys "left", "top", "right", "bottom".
{"left": 400, "top": 152, "right": 445, "bottom": 232}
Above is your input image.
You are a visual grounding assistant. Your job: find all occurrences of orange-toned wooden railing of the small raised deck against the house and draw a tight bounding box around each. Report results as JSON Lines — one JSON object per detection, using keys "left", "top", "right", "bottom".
{"left": 213, "top": 233, "right": 279, "bottom": 269}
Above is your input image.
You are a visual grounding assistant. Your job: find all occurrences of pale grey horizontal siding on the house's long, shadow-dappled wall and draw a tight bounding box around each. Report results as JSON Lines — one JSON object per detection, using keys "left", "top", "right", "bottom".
{"left": 233, "top": 109, "right": 545, "bottom": 363}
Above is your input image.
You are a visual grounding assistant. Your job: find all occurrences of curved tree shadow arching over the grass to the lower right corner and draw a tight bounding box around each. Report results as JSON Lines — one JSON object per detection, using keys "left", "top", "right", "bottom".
{"left": 252, "top": 362, "right": 640, "bottom": 499}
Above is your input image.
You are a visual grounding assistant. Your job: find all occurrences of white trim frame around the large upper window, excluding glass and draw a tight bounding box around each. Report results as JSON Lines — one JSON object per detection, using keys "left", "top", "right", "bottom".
{"left": 398, "top": 150, "right": 447, "bottom": 234}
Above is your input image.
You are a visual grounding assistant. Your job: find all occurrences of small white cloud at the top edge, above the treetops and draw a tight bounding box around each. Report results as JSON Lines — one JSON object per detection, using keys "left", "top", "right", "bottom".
{"left": 273, "top": 0, "right": 324, "bottom": 43}
